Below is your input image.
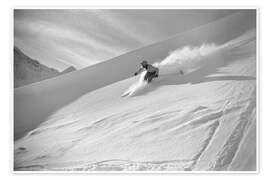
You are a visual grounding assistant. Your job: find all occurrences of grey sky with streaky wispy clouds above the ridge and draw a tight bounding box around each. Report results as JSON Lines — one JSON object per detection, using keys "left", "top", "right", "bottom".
{"left": 14, "top": 9, "right": 237, "bottom": 71}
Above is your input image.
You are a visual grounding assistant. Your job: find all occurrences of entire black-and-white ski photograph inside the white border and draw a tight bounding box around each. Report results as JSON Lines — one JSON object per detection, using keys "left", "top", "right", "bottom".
{"left": 12, "top": 8, "right": 258, "bottom": 173}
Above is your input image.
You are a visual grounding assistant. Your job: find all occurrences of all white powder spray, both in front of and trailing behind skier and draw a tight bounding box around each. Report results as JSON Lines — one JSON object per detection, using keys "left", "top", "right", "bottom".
{"left": 122, "top": 29, "right": 256, "bottom": 96}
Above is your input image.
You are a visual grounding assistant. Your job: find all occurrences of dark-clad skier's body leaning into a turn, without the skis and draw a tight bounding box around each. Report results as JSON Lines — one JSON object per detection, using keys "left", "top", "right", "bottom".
{"left": 134, "top": 61, "right": 159, "bottom": 83}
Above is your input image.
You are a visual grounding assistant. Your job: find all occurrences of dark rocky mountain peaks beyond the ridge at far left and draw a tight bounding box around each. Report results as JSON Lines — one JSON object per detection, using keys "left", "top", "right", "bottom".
{"left": 14, "top": 46, "right": 76, "bottom": 88}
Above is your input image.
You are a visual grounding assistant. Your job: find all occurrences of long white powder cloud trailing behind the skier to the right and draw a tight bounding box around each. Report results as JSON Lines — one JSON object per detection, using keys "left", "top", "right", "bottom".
{"left": 153, "top": 29, "right": 256, "bottom": 75}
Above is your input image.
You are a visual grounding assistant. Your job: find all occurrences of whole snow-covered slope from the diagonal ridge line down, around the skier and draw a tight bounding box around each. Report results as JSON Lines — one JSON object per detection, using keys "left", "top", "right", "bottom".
{"left": 14, "top": 11, "right": 256, "bottom": 171}
